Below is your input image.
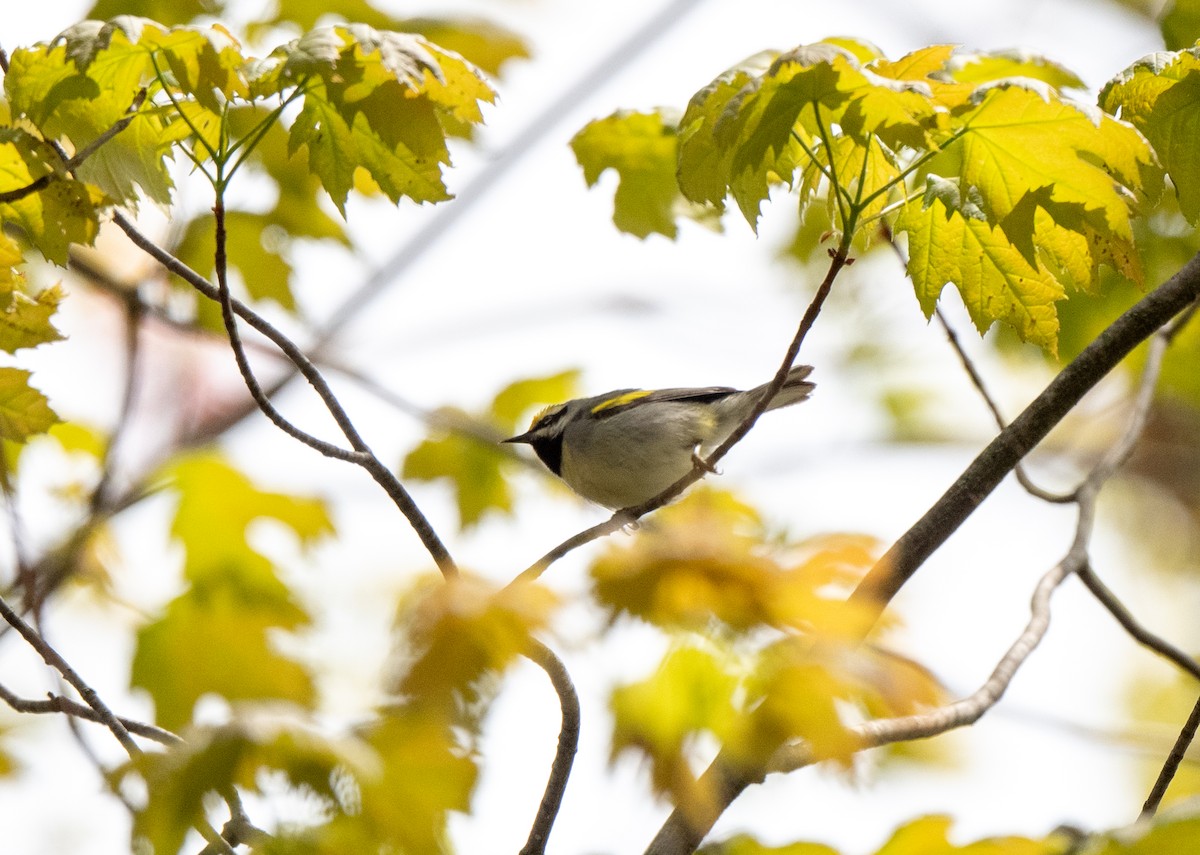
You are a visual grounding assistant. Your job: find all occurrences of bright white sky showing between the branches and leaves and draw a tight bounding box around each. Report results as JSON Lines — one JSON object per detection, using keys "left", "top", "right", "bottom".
{"left": 0, "top": 0, "right": 1185, "bottom": 855}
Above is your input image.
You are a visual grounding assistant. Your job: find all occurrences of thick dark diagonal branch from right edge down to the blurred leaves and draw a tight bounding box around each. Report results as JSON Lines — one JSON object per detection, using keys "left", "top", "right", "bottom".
{"left": 851, "top": 255, "right": 1200, "bottom": 614}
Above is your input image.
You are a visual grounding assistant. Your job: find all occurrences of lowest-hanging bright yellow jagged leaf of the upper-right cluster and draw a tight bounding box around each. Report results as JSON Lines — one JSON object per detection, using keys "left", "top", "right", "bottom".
{"left": 895, "top": 198, "right": 1066, "bottom": 352}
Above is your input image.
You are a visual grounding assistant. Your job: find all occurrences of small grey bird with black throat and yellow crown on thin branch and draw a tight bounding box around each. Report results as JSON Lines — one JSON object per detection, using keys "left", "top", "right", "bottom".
{"left": 502, "top": 365, "right": 816, "bottom": 510}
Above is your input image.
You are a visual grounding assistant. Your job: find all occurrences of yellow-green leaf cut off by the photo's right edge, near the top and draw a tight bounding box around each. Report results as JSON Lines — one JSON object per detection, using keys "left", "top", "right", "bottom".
{"left": 1100, "top": 48, "right": 1200, "bottom": 225}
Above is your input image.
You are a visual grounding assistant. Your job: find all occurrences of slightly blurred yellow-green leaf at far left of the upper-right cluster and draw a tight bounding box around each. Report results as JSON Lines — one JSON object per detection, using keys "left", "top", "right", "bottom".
{"left": 571, "top": 110, "right": 683, "bottom": 239}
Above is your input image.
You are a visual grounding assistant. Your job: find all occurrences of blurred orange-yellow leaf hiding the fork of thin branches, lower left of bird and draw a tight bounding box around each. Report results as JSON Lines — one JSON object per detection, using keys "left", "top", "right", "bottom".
{"left": 396, "top": 574, "right": 557, "bottom": 704}
